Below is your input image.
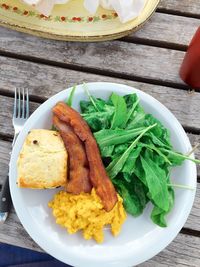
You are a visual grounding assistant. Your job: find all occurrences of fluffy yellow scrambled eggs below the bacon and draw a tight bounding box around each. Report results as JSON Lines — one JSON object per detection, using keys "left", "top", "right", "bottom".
{"left": 49, "top": 189, "right": 126, "bottom": 243}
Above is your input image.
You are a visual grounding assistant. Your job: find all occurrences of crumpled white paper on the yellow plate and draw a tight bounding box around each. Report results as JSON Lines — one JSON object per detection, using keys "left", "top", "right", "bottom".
{"left": 23, "top": 0, "right": 146, "bottom": 23}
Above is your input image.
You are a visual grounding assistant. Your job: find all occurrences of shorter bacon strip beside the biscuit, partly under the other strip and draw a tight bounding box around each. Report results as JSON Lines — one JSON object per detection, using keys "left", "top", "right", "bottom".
{"left": 53, "top": 115, "right": 92, "bottom": 194}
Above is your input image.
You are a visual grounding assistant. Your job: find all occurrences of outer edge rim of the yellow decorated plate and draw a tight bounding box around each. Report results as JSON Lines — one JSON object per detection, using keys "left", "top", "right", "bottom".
{"left": 0, "top": 0, "right": 160, "bottom": 42}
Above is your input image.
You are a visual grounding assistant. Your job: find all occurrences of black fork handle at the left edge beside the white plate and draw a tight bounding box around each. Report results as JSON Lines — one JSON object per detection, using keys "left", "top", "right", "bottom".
{"left": 0, "top": 176, "right": 11, "bottom": 212}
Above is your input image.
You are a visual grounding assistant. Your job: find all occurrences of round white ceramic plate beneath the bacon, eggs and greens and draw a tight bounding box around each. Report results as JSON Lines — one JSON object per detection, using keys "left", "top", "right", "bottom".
{"left": 10, "top": 83, "right": 197, "bottom": 267}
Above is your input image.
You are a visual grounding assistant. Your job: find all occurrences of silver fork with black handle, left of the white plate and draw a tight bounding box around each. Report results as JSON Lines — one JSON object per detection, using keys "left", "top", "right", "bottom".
{"left": 0, "top": 89, "right": 29, "bottom": 222}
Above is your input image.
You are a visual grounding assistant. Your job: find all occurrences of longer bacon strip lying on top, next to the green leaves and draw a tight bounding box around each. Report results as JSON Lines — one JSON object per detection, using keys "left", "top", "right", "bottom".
{"left": 53, "top": 102, "right": 117, "bottom": 211}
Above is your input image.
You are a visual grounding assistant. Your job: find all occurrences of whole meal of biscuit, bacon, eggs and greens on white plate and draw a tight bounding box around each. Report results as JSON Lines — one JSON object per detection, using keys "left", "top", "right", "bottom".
{"left": 18, "top": 86, "right": 200, "bottom": 243}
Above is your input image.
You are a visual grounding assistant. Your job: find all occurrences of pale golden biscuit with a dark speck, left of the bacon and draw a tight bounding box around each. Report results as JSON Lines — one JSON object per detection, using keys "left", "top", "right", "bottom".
{"left": 17, "top": 129, "right": 68, "bottom": 189}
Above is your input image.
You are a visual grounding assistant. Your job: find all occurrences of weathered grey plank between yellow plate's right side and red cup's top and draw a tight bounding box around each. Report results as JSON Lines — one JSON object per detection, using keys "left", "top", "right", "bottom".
{"left": 131, "top": 12, "right": 200, "bottom": 49}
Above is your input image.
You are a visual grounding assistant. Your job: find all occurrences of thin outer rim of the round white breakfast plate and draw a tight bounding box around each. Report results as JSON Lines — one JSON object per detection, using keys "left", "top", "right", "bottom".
{"left": 9, "top": 82, "right": 197, "bottom": 267}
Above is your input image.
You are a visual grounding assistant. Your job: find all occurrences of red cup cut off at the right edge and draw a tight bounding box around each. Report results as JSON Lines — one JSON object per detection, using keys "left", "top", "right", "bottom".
{"left": 180, "top": 27, "right": 200, "bottom": 90}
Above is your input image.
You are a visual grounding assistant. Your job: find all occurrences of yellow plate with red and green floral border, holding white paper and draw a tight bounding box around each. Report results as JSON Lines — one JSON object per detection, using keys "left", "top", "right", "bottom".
{"left": 0, "top": 0, "right": 159, "bottom": 41}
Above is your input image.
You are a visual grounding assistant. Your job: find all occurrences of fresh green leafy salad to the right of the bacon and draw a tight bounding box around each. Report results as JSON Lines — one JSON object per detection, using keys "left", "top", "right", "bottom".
{"left": 68, "top": 87, "right": 200, "bottom": 227}
